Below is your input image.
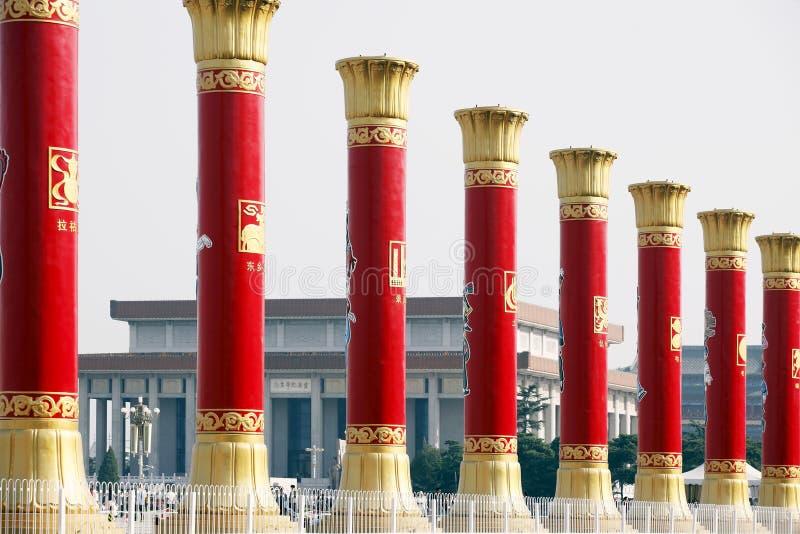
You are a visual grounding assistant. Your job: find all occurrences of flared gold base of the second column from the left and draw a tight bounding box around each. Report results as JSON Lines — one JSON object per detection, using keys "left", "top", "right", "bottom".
{"left": 189, "top": 432, "right": 280, "bottom": 515}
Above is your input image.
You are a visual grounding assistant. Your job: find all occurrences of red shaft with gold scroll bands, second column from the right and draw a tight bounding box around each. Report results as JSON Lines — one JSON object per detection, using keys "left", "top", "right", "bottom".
{"left": 705, "top": 268, "right": 747, "bottom": 473}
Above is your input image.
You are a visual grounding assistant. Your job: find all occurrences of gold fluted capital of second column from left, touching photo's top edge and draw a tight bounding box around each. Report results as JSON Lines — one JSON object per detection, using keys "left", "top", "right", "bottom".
{"left": 183, "top": 0, "right": 281, "bottom": 65}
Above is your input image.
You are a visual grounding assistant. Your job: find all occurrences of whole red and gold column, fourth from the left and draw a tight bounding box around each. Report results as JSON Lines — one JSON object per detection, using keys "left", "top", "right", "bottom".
{"left": 455, "top": 107, "right": 530, "bottom": 530}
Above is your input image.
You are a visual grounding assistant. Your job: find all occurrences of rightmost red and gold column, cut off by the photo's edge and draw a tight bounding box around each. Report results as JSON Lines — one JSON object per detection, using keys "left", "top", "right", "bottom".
{"left": 756, "top": 234, "right": 800, "bottom": 509}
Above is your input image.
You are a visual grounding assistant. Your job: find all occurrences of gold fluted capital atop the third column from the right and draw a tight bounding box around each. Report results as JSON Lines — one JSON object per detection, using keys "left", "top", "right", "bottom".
{"left": 628, "top": 181, "right": 691, "bottom": 228}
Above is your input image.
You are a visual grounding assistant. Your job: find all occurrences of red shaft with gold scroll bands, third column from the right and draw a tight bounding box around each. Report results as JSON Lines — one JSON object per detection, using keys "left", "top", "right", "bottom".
{"left": 638, "top": 244, "right": 683, "bottom": 468}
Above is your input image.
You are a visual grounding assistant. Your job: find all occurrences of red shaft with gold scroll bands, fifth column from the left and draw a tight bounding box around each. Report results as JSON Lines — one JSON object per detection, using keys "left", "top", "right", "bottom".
{"left": 559, "top": 214, "right": 608, "bottom": 461}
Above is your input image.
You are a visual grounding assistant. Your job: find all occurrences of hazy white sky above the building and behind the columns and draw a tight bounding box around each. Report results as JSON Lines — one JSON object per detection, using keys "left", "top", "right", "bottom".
{"left": 80, "top": 0, "right": 800, "bottom": 366}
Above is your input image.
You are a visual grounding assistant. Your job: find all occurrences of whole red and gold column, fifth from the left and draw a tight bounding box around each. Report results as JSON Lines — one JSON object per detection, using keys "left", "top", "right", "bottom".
{"left": 550, "top": 148, "right": 618, "bottom": 518}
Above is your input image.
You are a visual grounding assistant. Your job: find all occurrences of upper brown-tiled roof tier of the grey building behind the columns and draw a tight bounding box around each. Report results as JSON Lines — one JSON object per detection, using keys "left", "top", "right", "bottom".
{"left": 111, "top": 297, "right": 625, "bottom": 343}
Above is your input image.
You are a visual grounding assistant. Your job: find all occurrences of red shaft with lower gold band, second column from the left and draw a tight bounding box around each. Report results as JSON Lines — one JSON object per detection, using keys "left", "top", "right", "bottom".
{"left": 197, "top": 82, "right": 266, "bottom": 432}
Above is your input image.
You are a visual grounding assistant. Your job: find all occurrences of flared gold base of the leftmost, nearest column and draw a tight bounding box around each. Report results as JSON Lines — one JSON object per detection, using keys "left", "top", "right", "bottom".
{"left": 0, "top": 418, "right": 97, "bottom": 513}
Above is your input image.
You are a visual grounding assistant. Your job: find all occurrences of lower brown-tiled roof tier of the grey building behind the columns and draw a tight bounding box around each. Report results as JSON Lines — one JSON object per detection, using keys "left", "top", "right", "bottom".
{"left": 78, "top": 351, "right": 636, "bottom": 391}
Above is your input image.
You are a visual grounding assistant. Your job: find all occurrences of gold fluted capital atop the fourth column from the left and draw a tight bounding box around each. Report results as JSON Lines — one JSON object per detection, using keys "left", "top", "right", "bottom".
{"left": 454, "top": 106, "right": 528, "bottom": 163}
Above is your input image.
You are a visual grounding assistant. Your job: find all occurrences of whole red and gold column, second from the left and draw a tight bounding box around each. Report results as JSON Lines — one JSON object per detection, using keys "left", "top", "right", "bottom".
{"left": 184, "top": 0, "right": 280, "bottom": 512}
